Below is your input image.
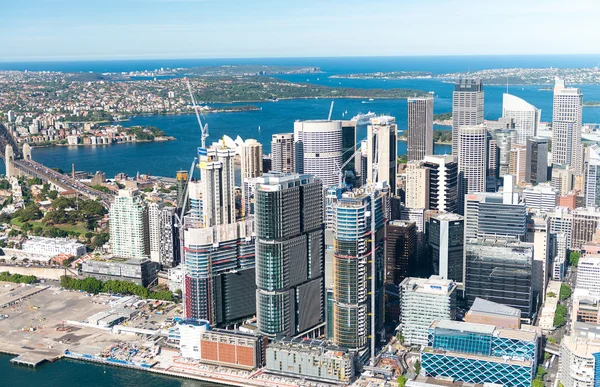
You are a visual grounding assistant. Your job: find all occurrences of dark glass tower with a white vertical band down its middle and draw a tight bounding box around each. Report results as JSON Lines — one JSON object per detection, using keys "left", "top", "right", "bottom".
{"left": 428, "top": 213, "right": 465, "bottom": 283}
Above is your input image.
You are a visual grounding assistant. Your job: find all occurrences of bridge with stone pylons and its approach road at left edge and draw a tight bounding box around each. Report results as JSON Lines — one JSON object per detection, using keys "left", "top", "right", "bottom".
{"left": 0, "top": 123, "right": 114, "bottom": 208}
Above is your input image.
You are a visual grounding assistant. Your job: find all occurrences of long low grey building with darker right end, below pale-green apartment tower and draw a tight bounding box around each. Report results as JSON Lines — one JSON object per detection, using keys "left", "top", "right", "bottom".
{"left": 82, "top": 258, "right": 159, "bottom": 286}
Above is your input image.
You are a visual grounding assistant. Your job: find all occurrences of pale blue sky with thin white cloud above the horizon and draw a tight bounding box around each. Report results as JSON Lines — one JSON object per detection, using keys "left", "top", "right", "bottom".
{"left": 0, "top": 0, "right": 600, "bottom": 62}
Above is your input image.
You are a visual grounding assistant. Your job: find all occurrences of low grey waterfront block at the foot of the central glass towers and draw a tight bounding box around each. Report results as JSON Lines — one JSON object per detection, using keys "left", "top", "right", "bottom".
{"left": 266, "top": 338, "right": 354, "bottom": 383}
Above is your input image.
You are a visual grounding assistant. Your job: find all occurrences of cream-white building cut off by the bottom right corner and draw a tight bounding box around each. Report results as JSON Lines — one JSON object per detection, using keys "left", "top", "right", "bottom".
{"left": 557, "top": 335, "right": 600, "bottom": 387}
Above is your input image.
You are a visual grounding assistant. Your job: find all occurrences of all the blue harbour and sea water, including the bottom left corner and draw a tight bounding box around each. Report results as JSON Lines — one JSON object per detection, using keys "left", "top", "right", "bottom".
{"left": 0, "top": 56, "right": 600, "bottom": 387}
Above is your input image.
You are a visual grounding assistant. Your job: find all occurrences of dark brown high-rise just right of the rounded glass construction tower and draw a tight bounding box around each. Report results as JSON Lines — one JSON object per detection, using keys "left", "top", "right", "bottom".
{"left": 385, "top": 220, "right": 417, "bottom": 285}
